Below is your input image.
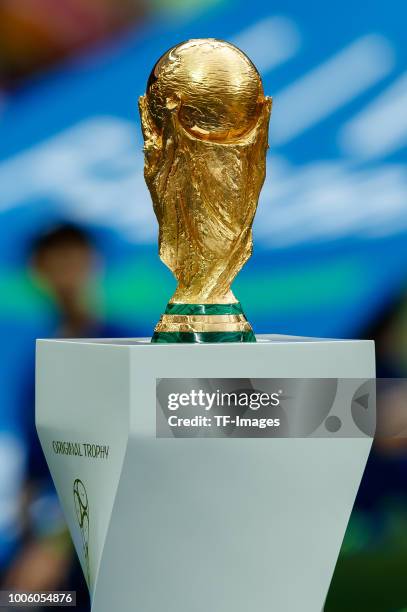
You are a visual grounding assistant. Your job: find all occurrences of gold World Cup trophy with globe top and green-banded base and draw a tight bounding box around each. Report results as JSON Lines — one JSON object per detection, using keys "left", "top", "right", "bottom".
{"left": 139, "top": 38, "right": 271, "bottom": 343}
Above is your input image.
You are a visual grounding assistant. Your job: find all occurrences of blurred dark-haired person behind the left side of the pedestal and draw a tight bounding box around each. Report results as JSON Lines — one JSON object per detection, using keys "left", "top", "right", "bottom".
{"left": 3, "top": 223, "right": 137, "bottom": 611}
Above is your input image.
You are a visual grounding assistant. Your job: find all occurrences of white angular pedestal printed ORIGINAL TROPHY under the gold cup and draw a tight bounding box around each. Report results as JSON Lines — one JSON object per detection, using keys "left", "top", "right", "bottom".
{"left": 37, "top": 336, "right": 374, "bottom": 612}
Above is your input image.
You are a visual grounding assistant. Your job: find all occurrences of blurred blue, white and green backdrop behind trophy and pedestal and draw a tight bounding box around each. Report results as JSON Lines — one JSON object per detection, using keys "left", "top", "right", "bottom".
{"left": 0, "top": 0, "right": 407, "bottom": 612}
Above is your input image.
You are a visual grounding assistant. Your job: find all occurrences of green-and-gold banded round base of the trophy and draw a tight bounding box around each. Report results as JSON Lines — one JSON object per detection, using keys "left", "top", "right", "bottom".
{"left": 151, "top": 302, "right": 256, "bottom": 343}
